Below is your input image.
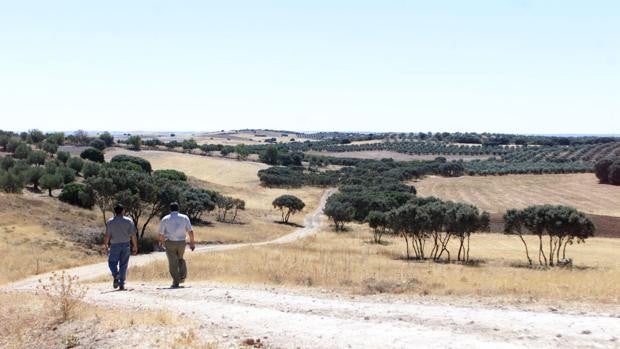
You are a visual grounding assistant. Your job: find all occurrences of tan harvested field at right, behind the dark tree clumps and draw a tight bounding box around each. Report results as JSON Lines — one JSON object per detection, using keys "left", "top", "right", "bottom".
{"left": 413, "top": 173, "right": 620, "bottom": 216}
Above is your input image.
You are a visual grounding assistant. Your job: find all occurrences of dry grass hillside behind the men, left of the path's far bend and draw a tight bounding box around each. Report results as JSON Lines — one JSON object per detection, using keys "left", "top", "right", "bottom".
{"left": 106, "top": 148, "right": 323, "bottom": 243}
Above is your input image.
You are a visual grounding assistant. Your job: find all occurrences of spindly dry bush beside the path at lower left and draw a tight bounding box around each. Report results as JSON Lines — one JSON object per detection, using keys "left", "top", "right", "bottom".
{"left": 38, "top": 271, "right": 87, "bottom": 322}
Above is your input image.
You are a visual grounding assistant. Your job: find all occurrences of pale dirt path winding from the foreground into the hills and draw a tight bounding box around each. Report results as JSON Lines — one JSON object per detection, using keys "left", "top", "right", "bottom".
{"left": 5, "top": 190, "right": 620, "bottom": 348}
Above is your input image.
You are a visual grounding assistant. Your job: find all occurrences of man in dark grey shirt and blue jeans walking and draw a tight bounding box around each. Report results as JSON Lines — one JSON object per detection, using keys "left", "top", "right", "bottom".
{"left": 103, "top": 204, "right": 138, "bottom": 291}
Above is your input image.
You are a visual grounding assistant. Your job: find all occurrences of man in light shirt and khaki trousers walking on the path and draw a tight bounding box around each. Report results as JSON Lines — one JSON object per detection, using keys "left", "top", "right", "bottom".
{"left": 159, "top": 202, "right": 196, "bottom": 288}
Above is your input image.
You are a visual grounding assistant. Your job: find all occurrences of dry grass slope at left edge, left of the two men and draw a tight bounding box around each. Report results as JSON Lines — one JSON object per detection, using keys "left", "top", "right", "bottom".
{"left": 0, "top": 193, "right": 103, "bottom": 284}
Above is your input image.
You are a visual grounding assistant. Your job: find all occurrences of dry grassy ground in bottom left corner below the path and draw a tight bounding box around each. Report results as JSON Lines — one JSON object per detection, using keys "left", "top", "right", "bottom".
{"left": 0, "top": 293, "right": 218, "bottom": 349}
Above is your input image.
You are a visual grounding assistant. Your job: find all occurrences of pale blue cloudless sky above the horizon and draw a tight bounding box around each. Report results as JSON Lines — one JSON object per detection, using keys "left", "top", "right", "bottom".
{"left": 0, "top": 0, "right": 620, "bottom": 134}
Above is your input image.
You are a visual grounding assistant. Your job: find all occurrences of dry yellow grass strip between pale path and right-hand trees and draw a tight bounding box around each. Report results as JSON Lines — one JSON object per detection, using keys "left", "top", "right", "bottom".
{"left": 130, "top": 225, "right": 620, "bottom": 304}
